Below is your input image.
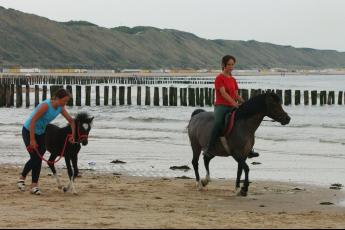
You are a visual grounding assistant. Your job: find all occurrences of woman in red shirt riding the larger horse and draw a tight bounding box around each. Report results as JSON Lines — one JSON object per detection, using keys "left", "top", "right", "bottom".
{"left": 204, "top": 55, "right": 259, "bottom": 158}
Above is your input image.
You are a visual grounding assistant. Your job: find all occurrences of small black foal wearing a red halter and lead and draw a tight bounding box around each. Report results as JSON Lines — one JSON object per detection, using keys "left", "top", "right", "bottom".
{"left": 46, "top": 113, "right": 94, "bottom": 194}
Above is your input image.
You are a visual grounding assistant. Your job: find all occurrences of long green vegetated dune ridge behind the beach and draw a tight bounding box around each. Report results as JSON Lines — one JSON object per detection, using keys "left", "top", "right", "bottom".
{"left": 0, "top": 7, "right": 345, "bottom": 69}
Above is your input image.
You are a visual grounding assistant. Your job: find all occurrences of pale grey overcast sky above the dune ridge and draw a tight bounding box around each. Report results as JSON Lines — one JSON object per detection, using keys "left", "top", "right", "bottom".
{"left": 0, "top": 0, "right": 345, "bottom": 51}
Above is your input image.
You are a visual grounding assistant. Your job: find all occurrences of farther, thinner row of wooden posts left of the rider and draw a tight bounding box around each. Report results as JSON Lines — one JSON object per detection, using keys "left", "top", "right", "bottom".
{"left": 0, "top": 75, "right": 214, "bottom": 85}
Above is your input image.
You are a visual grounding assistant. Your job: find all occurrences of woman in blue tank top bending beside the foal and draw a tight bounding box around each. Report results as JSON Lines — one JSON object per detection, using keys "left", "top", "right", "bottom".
{"left": 17, "top": 89, "right": 75, "bottom": 195}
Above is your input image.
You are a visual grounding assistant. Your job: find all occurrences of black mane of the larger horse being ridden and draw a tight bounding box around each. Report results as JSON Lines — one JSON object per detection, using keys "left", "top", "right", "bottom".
{"left": 235, "top": 93, "right": 281, "bottom": 120}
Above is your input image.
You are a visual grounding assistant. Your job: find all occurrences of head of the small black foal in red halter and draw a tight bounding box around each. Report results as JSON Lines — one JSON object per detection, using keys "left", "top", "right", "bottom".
{"left": 74, "top": 113, "right": 94, "bottom": 146}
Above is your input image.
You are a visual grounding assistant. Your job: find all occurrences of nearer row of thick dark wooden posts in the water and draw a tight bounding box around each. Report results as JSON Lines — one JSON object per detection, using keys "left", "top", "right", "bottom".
{"left": 0, "top": 84, "right": 345, "bottom": 107}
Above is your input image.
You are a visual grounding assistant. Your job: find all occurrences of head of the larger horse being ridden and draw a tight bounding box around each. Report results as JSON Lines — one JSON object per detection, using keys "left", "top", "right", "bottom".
{"left": 265, "top": 93, "right": 291, "bottom": 125}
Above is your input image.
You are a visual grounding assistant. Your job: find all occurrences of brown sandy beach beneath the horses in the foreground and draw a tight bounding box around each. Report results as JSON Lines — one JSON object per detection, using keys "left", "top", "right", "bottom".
{"left": 0, "top": 165, "right": 345, "bottom": 228}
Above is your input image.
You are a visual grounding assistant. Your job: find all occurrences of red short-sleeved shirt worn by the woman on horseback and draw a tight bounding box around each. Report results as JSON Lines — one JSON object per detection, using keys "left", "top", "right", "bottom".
{"left": 214, "top": 73, "right": 238, "bottom": 106}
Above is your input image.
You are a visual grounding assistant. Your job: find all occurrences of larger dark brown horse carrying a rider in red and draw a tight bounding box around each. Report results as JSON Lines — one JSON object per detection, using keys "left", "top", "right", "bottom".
{"left": 188, "top": 93, "right": 291, "bottom": 196}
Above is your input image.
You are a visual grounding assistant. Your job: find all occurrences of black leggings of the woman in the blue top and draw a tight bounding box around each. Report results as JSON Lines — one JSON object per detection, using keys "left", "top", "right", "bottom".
{"left": 22, "top": 127, "right": 46, "bottom": 183}
